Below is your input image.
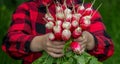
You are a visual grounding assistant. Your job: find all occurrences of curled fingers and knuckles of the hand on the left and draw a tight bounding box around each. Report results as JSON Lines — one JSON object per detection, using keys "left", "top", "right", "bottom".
{"left": 41, "top": 36, "right": 65, "bottom": 58}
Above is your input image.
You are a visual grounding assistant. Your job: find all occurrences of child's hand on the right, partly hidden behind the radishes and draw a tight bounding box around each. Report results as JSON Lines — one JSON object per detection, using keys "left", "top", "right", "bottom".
{"left": 74, "top": 31, "right": 95, "bottom": 53}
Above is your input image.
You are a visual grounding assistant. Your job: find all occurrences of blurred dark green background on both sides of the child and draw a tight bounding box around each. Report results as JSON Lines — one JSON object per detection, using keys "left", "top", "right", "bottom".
{"left": 0, "top": 0, "right": 120, "bottom": 64}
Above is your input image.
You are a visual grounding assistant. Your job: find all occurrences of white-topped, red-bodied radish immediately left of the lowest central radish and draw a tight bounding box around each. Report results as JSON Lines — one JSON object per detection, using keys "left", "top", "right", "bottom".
{"left": 53, "top": 26, "right": 62, "bottom": 40}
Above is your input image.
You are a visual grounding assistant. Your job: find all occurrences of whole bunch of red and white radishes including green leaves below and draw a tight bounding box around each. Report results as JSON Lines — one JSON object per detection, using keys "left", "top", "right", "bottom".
{"left": 32, "top": 0, "right": 102, "bottom": 64}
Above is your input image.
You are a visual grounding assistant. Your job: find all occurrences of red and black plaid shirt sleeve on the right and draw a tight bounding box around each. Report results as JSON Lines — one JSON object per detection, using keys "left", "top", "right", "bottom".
{"left": 88, "top": 10, "right": 114, "bottom": 61}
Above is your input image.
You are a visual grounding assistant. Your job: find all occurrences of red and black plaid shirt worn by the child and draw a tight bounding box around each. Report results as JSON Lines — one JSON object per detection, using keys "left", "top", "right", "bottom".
{"left": 2, "top": 0, "right": 114, "bottom": 64}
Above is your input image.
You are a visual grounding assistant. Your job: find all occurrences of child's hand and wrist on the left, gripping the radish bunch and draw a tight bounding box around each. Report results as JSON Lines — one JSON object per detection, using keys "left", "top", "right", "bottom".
{"left": 30, "top": 34, "right": 65, "bottom": 58}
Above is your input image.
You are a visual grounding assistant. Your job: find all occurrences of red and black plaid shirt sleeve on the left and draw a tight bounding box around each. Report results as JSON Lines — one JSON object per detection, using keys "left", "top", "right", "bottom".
{"left": 2, "top": 3, "right": 35, "bottom": 59}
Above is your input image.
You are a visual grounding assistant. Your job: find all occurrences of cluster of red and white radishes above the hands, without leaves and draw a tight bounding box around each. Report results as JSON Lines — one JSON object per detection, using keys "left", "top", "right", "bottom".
{"left": 44, "top": 0, "right": 101, "bottom": 51}
